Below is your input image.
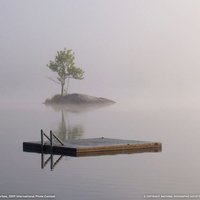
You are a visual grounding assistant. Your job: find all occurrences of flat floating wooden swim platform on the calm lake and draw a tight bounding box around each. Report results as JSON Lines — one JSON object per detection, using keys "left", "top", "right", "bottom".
{"left": 23, "top": 136, "right": 162, "bottom": 157}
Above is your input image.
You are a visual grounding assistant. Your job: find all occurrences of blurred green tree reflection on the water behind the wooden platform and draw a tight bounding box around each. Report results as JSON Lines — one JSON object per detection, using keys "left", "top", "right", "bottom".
{"left": 54, "top": 110, "right": 84, "bottom": 140}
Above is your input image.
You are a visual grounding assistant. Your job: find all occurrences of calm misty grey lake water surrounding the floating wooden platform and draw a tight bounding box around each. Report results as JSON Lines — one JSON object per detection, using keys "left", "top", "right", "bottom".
{"left": 0, "top": 103, "right": 200, "bottom": 200}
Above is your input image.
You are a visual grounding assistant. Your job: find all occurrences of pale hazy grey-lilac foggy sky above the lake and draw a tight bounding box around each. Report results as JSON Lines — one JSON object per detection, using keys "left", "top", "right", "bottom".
{"left": 0, "top": 0, "right": 200, "bottom": 108}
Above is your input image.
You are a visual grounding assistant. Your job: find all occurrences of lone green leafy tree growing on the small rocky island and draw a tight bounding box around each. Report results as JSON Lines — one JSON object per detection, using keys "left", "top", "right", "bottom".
{"left": 47, "top": 48, "right": 84, "bottom": 96}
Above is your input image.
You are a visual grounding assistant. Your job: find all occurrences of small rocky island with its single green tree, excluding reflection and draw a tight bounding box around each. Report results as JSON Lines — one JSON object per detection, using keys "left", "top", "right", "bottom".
{"left": 44, "top": 48, "right": 115, "bottom": 105}
